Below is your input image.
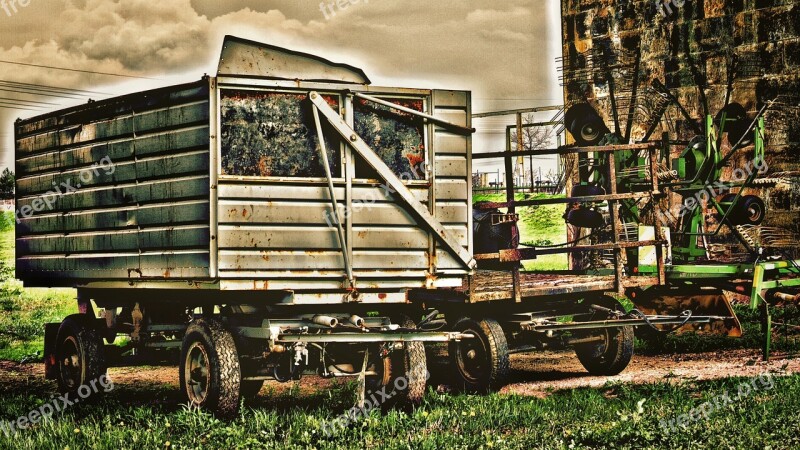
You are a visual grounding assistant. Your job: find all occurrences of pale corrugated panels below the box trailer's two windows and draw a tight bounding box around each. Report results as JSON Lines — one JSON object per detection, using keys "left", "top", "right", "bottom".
{"left": 217, "top": 180, "right": 429, "bottom": 290}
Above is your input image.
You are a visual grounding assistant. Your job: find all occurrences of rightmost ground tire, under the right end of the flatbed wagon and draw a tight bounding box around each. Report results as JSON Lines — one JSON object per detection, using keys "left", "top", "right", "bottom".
{"left": 575, "top": 298, "right": 634, "bottom": 376}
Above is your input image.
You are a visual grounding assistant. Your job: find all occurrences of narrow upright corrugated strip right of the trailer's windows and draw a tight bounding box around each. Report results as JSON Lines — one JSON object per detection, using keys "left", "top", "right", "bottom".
{"left": 433, "top": 90, "right": 472, "bottom": 268}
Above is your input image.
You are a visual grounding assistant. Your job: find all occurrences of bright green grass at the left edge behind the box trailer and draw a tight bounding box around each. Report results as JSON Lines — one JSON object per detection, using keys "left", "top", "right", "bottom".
{"left": 0, "top": 212, "right": 77, "bottom": 361}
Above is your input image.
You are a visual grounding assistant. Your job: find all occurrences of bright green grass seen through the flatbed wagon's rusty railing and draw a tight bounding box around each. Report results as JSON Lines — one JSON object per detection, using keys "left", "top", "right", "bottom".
{"left": 472, "top": 193, "right": 568, "bottom": 270}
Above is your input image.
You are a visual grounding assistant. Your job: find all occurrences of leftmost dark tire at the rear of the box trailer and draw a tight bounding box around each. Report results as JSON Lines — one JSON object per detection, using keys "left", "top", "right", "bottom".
{"left": 56, "top": 314, "right": 106, "bottom": 395}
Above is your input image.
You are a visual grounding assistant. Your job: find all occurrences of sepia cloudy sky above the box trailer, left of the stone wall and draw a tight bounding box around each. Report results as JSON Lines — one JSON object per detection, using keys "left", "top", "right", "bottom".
{"left": 0, "top": 0, "right": 560, "bottom": 172}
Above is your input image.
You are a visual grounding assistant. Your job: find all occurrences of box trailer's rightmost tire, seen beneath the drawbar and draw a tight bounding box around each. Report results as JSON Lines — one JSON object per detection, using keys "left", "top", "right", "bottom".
{"left": 385, "top": 314, "right": 430, "bottom": 408}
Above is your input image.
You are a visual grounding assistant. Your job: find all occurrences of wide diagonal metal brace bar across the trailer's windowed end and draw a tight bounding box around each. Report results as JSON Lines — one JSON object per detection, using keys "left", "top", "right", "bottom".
{"left": 308, "top": 92, "right": 477, "bottom": 269}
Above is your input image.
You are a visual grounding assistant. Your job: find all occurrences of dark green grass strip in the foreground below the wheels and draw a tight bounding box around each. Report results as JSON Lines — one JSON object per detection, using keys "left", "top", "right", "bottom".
{"left": 0, "top": 375, "right": 800, "bottom": 449}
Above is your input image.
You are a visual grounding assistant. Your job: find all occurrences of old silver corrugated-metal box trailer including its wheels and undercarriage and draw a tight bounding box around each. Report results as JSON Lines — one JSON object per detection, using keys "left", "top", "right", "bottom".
{"left": 15, "top": 37, "right": 475, "bottom": 415}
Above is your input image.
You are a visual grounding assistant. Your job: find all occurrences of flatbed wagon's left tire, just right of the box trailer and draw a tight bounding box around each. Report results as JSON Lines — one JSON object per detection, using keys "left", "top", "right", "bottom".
{"left": 450, "top": 317, "right": 511, "bottom": 394}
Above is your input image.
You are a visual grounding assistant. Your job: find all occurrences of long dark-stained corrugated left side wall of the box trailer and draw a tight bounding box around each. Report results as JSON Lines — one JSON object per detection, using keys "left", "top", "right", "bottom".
{"left": 16, "top": 80, "right": 211, "bottom": 286}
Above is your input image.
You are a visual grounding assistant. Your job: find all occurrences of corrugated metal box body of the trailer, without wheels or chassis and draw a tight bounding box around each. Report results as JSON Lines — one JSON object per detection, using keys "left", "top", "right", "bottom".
{"left": 16, "top": 39, "right": 471, "bottom": 304}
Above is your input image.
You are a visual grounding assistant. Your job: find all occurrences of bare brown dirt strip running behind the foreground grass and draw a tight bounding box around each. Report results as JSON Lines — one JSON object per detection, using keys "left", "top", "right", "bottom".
{"left": 0, "top": 350, "right": 800, "bottom": 397}
